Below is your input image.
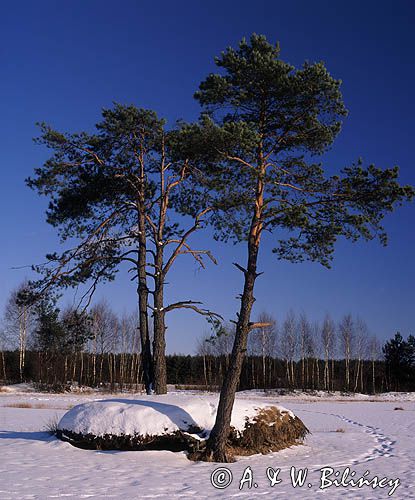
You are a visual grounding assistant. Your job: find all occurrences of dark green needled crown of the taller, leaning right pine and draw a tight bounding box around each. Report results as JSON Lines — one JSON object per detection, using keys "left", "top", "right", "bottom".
{"left": 177, "top": 35, "right": 414, "bottom": 266}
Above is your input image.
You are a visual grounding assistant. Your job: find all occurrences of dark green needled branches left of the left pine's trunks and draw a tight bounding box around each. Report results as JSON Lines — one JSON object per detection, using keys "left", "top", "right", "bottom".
{"left": 27, "top": 104, "right": 169, "bottom": 292}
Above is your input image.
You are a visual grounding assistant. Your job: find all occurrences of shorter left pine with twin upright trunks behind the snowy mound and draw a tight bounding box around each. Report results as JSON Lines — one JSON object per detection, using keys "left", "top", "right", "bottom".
{"left": 27, "top": 104, "right": 215, "bottom": 394}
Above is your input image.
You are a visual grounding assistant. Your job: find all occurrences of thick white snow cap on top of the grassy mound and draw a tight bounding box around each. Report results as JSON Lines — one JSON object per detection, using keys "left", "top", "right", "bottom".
{"left": 59, "top": 394, "right": 294, "bottom": 437}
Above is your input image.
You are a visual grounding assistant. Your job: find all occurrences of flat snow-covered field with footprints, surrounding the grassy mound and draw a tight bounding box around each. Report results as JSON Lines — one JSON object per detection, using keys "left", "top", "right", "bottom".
{"left": 0, "top": 390, "right": 415, "bottom": 500}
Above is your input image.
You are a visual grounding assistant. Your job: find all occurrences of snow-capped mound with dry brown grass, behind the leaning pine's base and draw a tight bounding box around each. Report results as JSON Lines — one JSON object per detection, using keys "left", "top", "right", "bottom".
{"left": 56, "top": 394, "right": 308, "bottom": 460}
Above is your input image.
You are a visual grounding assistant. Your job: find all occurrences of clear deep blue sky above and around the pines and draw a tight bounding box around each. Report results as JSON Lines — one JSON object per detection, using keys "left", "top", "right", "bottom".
{"left": 0, "top": 0, "right": 415, "bottom": 352}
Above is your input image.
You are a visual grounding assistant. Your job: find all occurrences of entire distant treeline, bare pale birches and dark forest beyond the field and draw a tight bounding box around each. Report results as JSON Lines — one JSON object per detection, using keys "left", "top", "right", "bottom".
{"left": 0, "top": 292, "right": 415, "bottom": 393}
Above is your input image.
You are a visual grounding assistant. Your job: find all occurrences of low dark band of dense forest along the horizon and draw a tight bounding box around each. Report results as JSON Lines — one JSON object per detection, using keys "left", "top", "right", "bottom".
{"left": 0, "top": 351, "right": 415, "bottom": 394}
